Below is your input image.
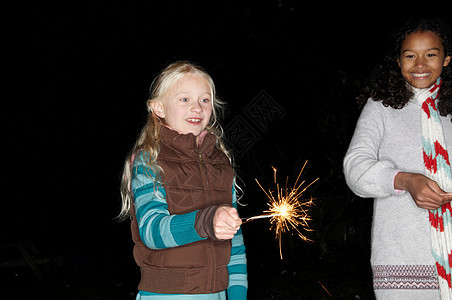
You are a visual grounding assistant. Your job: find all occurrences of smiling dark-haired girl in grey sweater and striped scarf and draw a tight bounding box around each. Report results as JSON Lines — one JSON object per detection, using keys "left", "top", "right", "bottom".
{"left": 344, "top": 18, "right": 452, "bottom": 299}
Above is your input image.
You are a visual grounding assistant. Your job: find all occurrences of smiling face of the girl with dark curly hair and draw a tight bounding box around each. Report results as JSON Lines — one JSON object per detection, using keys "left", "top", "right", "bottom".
{"left": 397, "top": 31, "right": 450, "bottom": 89}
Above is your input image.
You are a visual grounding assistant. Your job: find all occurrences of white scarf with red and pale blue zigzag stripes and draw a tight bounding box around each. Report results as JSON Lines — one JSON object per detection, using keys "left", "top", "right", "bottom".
{"left": 415, "top": 78, "right": 452, "bottom": 300}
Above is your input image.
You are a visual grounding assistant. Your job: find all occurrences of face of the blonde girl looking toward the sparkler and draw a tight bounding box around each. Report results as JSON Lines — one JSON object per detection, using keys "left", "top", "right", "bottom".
{"left": 151, "top": 73, "right": 212, "bottom": 137}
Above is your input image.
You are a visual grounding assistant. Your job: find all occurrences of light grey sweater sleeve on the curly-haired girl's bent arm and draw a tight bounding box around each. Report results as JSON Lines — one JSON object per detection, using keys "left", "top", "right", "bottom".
{"left": 344, "top": 99, "right": 402, "bottom": 198}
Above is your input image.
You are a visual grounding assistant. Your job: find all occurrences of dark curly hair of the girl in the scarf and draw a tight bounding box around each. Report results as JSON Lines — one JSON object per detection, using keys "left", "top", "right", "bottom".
{"left": 357, "top": 18, "right": 452, "bottom": 122}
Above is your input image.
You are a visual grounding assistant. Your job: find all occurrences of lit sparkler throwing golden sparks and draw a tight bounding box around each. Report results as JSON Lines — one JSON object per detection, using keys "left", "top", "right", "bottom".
{"left": 243, "top": 161, "right": 318, "bottom": 259}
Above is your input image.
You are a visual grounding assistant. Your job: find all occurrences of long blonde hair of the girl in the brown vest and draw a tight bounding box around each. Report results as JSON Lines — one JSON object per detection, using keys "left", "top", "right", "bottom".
{"left": 118, "top": 61, "right": 235, "bottom": 220}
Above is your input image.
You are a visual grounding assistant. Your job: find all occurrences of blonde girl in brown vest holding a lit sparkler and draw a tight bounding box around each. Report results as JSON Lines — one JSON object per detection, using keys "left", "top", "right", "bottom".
{"left": 120, "top": 61, "right": 247, "bottom": 300}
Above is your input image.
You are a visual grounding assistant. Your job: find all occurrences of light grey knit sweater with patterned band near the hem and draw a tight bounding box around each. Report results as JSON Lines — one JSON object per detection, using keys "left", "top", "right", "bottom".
{"left": 344, "top": 99, "right": 452, "bottom": 300}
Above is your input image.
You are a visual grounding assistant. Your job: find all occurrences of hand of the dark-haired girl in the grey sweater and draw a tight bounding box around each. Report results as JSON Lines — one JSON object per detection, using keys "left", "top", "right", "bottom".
{"left": 394, "top": 172, "right": 452, "bottom": 210}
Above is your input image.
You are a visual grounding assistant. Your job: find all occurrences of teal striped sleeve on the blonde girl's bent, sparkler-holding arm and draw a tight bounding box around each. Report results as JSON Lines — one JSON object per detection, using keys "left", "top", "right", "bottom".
{"left": 132, "top": 154, "right": 204, "bottom": 249}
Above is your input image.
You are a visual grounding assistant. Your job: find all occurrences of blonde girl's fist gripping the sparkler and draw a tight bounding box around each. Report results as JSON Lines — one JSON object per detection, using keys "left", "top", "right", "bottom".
{"left": 213, "top": 205, "right": 242, "bottom": 240}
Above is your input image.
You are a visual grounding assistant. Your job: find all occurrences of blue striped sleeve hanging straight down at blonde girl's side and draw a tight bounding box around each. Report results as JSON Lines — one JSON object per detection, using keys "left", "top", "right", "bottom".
{"left": 228, "top": 189, "right": 248, "bottom": 300}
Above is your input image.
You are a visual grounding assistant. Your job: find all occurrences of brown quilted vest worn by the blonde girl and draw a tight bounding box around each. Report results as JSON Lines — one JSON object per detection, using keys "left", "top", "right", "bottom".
{"left": 131, "top": 127, "right": 233, "bottom": 294}
